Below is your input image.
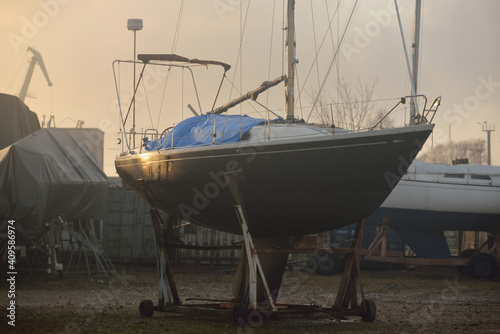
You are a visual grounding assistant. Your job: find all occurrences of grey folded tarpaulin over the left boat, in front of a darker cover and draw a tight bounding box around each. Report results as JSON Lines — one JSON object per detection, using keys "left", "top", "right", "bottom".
{"left": 0, "top": 128, "right": 108, "bottom": 240}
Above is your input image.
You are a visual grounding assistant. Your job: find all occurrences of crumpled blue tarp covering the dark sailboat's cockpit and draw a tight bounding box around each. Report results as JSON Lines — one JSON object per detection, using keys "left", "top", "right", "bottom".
{"left": 145, "top": 114, "right": 266, "bottom": 151}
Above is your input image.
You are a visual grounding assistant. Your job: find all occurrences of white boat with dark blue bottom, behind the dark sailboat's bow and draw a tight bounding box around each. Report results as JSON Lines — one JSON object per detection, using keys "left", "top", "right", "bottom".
{"left": 367, "top": 160, "right": 500, "bottom": 257}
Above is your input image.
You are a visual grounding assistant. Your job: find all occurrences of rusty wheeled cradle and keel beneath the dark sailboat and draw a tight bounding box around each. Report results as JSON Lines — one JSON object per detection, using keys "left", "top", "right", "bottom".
{"left": 139, "top": 171, "right": 376, "bottom": 327}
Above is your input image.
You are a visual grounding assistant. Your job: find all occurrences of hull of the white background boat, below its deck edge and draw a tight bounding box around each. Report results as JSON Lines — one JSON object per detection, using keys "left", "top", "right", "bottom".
{"left": 367, "top": 179, "right": 500, "bottom": 232}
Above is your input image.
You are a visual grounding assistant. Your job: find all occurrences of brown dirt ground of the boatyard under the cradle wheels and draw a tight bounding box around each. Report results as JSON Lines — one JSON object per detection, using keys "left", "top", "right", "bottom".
{"left": 0, "top": 265, "right": 500, "bottom": 333}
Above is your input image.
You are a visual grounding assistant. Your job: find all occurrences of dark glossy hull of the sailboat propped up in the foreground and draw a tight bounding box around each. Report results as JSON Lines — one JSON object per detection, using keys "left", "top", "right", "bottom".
{"left": 116, "top": 125, "right": 433, "bottom": 237}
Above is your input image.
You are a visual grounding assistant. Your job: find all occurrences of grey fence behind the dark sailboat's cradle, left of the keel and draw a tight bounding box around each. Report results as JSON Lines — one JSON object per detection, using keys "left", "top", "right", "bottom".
{"left": 102, "top": 187, "right": 241, "bottom": 264}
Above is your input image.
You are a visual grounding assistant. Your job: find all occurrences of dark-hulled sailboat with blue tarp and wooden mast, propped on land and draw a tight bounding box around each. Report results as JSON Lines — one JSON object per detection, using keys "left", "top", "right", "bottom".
{"left": 115, "top": 0, "right": 434, "bottom": 237}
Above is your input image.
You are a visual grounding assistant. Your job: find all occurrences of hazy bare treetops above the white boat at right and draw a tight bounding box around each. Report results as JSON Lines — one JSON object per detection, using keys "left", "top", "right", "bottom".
{"left": 418, "top": 139, "right": 486, "bottom": 164}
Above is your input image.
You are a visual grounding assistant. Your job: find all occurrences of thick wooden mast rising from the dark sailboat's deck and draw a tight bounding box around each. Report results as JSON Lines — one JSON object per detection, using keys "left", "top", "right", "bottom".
{"left": 286, "top": 0, "right": 296, "bottom": 121}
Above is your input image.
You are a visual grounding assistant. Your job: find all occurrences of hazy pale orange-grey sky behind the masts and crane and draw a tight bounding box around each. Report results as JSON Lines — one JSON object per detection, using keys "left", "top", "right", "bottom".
{"left": 0, "top": 0, "right": 500, "bottom": 176}
